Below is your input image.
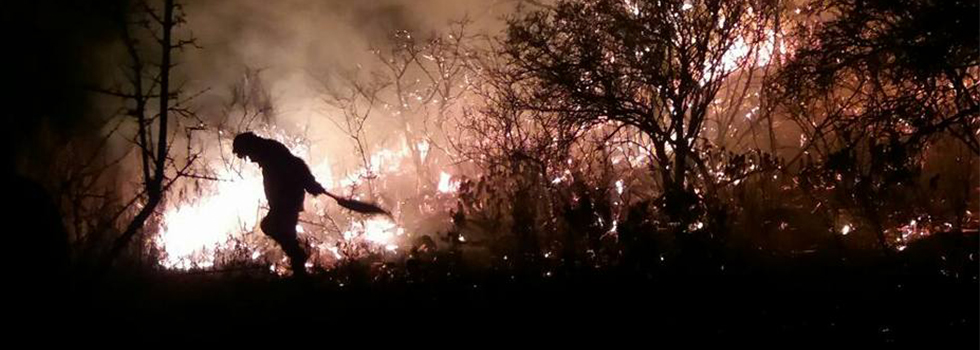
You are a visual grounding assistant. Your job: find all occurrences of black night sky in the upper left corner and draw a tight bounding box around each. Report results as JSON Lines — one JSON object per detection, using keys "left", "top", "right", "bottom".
{"left": 2, "top": 0, "right": 112, "bottom": 170}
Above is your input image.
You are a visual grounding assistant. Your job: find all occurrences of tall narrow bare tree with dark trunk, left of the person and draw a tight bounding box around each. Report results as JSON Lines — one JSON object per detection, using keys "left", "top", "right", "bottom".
{"left": 93, "top": 0, "right": 204, "bottom": 267}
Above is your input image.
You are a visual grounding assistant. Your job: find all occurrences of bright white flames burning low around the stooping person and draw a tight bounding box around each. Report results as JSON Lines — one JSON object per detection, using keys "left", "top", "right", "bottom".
{"left": 154, "top": 131, "right": 416, "bottom": 272}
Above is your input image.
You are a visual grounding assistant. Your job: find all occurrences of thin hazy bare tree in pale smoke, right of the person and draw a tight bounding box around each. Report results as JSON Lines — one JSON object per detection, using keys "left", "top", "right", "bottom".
{"left": 322, "top": 20, "right": 469, "bottom": 192}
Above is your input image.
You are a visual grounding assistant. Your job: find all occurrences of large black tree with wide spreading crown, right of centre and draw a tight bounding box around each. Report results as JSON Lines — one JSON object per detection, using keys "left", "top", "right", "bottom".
{"left": 503, "top": 0, "right": 772, "bottom": 227}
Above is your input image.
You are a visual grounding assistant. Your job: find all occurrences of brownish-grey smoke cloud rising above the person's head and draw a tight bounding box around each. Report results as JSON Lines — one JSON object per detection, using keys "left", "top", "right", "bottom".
{"left": 179, "top": 0, "right": 528, "bottom": 164}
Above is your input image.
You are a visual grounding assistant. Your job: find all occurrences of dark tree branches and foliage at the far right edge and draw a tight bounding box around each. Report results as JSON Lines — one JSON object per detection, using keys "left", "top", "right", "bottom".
{"left": 771, "top": 0, "right": 980, "bottom": 251}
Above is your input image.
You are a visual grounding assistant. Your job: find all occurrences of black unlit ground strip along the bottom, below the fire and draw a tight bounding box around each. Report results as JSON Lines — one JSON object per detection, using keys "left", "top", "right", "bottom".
{"left": 16, "top": 235, "right": 980, "bottom": 349}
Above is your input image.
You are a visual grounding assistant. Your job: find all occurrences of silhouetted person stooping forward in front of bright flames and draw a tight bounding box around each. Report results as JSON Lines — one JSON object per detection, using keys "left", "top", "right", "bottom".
{"left": 232, "top": 132, "right": 327, "bottom": 277}
